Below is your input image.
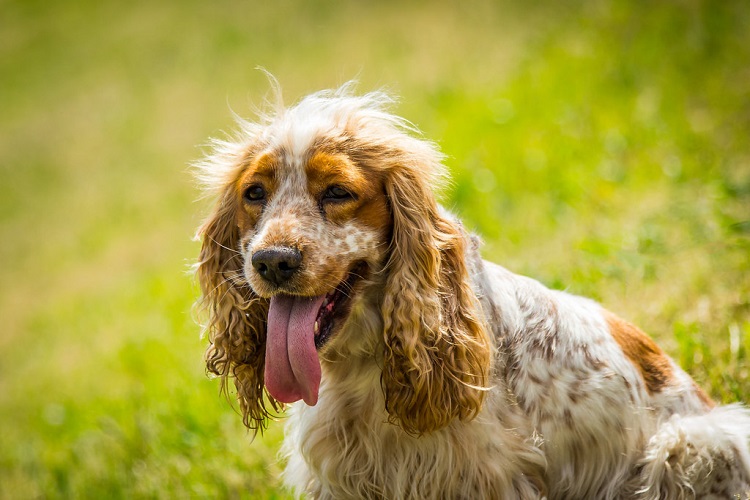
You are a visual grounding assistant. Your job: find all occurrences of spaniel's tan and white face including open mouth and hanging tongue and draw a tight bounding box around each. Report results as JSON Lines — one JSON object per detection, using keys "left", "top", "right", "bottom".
{"left": 236, "top": 148, "right": 391, "bottom": 403}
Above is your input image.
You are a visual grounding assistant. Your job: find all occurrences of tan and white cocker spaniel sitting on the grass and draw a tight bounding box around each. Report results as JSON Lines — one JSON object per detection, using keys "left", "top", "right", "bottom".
{"left": 197, "top": 85, "right": 750, "bottom": 499}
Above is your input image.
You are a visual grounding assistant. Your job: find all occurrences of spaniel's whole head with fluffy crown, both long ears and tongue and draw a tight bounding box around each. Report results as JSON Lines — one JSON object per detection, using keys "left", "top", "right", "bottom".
{"left": 198, "top": 88, "right": 490, "bottom": 433}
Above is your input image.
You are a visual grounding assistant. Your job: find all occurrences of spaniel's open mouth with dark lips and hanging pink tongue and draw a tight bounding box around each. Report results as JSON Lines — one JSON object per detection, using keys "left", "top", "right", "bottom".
{"left": 264, "top": 263, "right": 368, "bottom": 406}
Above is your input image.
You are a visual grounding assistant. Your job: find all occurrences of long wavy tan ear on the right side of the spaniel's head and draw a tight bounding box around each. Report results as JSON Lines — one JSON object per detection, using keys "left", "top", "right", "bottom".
{"left": 383, "top": 166, "right": 490, "bottom": 434}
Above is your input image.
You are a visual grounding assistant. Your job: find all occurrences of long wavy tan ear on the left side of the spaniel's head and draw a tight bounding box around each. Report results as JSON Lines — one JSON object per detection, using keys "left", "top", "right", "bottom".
{"left": 196, "top": 189, "right": 280, "bottom": 432}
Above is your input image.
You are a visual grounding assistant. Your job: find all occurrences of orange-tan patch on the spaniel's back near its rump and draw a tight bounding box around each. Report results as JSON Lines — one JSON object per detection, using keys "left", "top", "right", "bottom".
{"left": 604, "top": 311, "right": 674, "bottom": 394}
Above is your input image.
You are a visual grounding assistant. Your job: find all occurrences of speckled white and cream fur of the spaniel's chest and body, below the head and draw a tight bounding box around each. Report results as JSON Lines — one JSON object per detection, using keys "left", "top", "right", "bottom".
{"left": 282, "top": 252, "right": 750, "bottom": 499}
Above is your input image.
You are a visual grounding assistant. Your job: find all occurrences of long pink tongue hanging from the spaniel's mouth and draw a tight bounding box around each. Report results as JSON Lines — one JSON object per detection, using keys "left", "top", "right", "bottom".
{"left": 265, "top": 295, "right": 325, "bottom": 406}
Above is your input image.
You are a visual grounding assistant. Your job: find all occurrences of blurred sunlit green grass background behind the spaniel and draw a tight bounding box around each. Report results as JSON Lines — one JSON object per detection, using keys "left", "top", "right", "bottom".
{"left": 0, "top": 0, "right": 750, "bottom": 498}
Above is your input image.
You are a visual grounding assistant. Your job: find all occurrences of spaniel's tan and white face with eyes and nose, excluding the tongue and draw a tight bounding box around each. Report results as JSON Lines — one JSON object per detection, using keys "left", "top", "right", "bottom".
{"left": 237, "top": 150, "right": 390, "bottom": 298}
